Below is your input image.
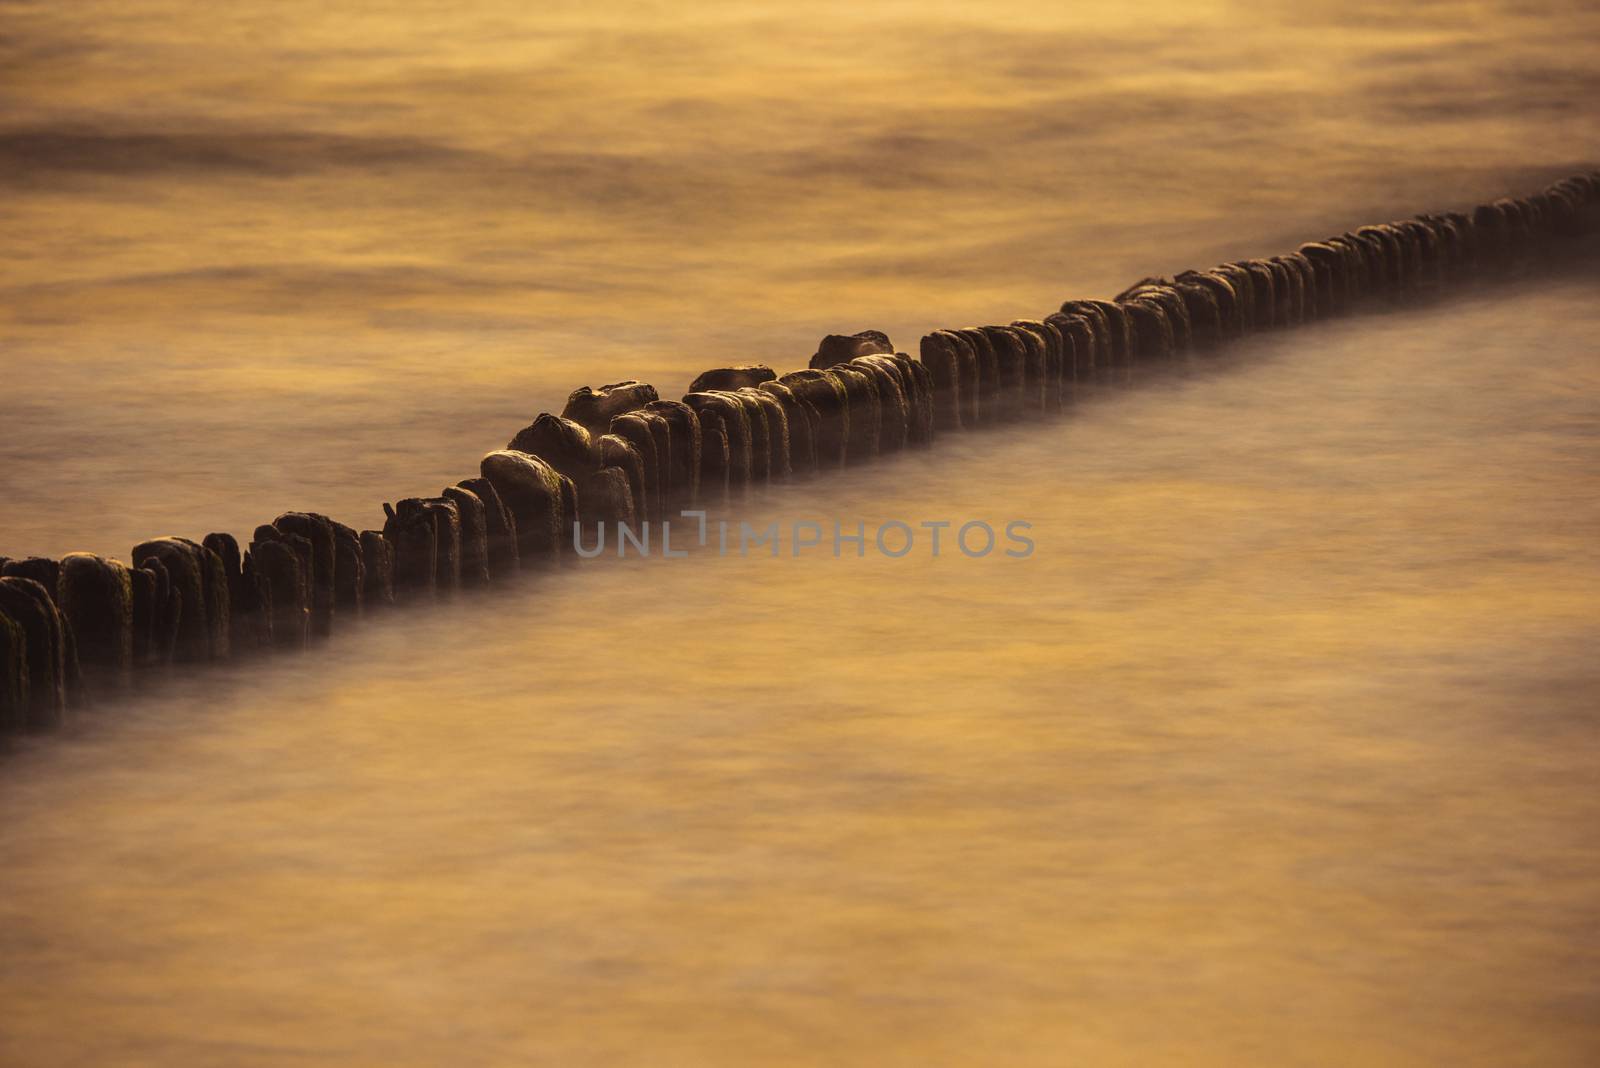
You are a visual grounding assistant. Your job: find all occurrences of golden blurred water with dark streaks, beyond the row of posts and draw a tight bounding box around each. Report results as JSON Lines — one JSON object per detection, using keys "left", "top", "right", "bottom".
{"left": 0, "top": 0, "right": 1600, "bottom": 556}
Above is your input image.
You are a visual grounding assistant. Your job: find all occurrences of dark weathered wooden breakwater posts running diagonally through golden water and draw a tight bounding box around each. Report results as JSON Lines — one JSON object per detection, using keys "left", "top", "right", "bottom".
{"left": 0, "top": 173, "right": 1600, "bottom": 734}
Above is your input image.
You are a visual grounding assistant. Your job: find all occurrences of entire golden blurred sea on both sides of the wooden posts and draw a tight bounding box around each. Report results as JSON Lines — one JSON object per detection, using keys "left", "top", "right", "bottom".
{"left": 0, "top": 0, "right": 1600, "bottom": 1065}
